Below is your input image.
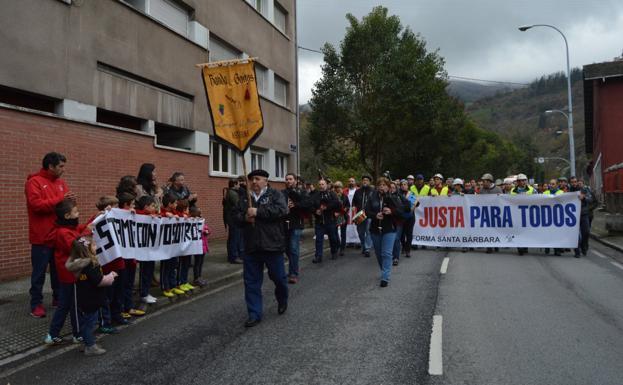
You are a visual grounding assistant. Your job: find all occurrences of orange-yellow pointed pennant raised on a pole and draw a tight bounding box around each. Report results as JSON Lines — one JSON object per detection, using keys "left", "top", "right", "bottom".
{"left": 199, "top": 58, "right": 264, "bottom": 153}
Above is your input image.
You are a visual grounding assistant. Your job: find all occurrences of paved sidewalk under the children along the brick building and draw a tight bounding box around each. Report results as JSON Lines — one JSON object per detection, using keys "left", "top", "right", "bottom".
{"left": 0, "top": 229, "right": 314, "bottom": 367}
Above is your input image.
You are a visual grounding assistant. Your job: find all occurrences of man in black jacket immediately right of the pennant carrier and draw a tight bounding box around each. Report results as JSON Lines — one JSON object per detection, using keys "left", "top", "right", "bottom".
{"left": 282, "top": 173, "right": 311, "bottom": 283}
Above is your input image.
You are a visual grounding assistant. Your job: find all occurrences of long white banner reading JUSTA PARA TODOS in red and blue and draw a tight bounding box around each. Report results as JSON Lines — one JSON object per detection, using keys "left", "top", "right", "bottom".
{"left": 413, "top": 193, "right": 580, "bottom": 248}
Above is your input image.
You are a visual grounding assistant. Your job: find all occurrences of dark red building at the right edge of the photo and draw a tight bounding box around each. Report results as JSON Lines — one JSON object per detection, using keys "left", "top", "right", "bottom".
{"left": 584, "top": 58, "right": 623, "bottom": 231}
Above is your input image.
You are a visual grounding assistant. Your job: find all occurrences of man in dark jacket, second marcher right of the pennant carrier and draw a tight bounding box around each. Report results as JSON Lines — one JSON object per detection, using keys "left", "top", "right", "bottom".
{"left": 310, "top": 179, "right": 340, "bottom": 263}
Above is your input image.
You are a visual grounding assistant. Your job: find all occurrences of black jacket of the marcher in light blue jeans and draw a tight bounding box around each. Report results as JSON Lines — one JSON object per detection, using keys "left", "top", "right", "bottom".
{"left": 365, "top": 191, "right": 409, "bottom": 234}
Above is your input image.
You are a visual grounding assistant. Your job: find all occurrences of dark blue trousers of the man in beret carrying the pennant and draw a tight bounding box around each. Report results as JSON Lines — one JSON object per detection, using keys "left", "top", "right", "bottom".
{"left": 243, "top": 252, "right": 288, "bottom": 320}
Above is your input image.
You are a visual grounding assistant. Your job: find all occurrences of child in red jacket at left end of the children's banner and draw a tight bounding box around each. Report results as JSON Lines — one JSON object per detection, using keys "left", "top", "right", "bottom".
{"left": 44, "top": 199, "right": 92, "bottom": 345}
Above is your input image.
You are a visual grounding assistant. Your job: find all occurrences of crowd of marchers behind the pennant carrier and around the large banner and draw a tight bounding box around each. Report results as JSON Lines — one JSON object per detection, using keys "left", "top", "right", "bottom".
{"left": 223, "top": 173, "right": 596, "bottom": 287}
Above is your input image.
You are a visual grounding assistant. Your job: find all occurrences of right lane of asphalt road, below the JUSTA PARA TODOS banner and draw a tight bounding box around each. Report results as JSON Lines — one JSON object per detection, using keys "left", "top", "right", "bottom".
{"left": 431, "top": 245, "right": 623, "bottom": 385}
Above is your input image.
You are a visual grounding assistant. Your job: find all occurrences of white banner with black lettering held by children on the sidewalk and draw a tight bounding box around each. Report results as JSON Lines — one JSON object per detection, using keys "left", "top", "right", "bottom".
{"left": 93, "top": 209, "right": 204, "bottom": 265}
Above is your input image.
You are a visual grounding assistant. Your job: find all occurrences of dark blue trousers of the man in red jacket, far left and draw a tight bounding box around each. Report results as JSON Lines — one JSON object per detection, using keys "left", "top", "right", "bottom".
{"left": 30, "top": 245, "right": 59, "bottom": 310}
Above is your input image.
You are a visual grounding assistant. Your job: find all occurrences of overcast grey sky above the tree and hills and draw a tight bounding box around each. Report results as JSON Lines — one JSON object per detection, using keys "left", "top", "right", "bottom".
{"left": 297, "top": 0, "right": 623, "bottom": 104}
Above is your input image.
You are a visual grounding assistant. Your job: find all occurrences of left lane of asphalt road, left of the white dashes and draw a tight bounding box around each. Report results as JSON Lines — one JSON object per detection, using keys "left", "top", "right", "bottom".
{"left": 5, "top": 249, "right": 442, "bottom": 385}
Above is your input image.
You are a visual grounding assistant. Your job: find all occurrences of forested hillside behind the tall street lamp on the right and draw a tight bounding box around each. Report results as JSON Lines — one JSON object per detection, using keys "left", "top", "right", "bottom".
{"left": 463, "top": 69, "right": 588, "bottom": 179}
